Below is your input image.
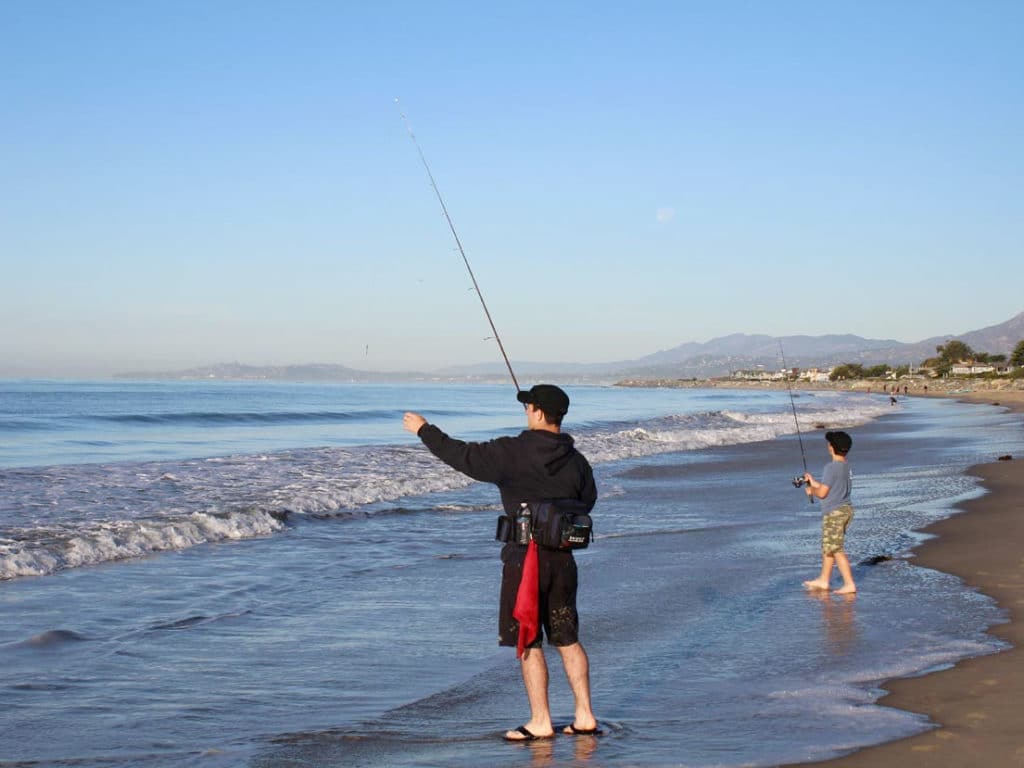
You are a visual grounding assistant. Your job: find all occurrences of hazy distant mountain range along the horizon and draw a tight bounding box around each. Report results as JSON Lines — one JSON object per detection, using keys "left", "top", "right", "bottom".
{"left": 116, "top": 312, "right": 1024, "bottom": 383}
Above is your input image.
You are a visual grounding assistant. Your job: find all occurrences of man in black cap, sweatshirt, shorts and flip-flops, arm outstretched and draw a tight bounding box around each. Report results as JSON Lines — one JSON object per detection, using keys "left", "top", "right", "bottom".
{"left": 403, "top": 384, "right": 601, "bottom": 741}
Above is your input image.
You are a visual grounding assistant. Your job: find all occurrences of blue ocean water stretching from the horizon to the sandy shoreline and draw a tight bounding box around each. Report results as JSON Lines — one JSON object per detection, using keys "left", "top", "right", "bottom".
{"left": 0, "top": 381, "right": 1024, "bottom": 768}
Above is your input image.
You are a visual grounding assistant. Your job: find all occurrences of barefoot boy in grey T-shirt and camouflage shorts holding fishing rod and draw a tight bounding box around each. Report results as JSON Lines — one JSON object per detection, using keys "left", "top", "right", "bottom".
{"left": 804, "top": 432, "right": 857, "bottom": 595}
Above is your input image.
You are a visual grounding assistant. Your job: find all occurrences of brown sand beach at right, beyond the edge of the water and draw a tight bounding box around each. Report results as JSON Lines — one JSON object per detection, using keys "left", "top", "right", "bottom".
{"left": 790, "top": 391, "right": 1024, "bottom": 768}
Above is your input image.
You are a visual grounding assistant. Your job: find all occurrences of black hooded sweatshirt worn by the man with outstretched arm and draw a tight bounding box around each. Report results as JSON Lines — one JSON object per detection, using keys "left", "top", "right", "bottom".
{"left": 418, "top": 424, "right": 597, "bottom": 517}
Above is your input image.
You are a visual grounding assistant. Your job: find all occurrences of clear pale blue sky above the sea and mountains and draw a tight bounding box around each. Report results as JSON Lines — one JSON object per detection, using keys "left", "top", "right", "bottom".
{"left": 0, "top": 0, "right": 1024, "bottom": 377}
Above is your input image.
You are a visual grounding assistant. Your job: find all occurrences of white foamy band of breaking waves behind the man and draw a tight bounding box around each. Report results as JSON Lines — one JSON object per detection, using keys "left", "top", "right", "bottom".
{"left": 0, "top": 397, "right": 886, "bottom": 579}
